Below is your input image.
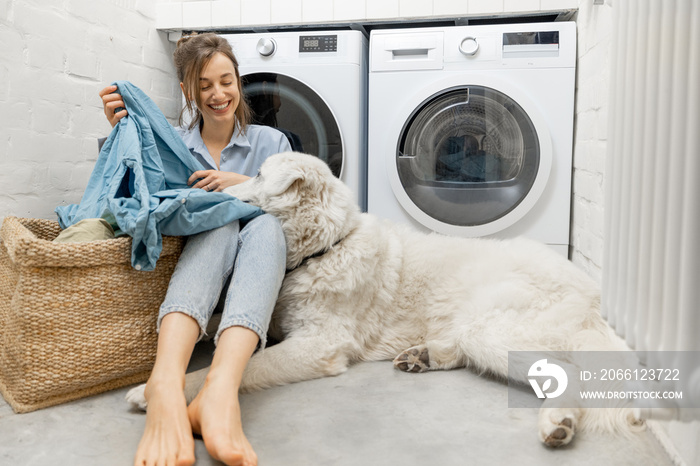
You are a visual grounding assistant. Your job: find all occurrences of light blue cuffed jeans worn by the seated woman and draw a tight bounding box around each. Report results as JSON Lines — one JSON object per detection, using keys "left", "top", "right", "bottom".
{"left": 158, "top": 214, "right": 287, "bottom": 348}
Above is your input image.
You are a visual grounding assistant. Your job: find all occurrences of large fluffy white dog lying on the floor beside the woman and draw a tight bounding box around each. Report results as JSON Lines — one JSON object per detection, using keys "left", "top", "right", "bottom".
{"left": 127, "top": 153, "right": 641, "bottom": 446}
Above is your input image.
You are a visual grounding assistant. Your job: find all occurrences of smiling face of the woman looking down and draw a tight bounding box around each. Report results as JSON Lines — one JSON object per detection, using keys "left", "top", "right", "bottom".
{"left": 199, "top": 53, "right": 241, "bottom": 128}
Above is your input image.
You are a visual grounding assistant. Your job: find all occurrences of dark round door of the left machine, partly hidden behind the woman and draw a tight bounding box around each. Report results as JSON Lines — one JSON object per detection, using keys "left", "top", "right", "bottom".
{"left": 241, "top": 73, "right": 343, "bottom": 178}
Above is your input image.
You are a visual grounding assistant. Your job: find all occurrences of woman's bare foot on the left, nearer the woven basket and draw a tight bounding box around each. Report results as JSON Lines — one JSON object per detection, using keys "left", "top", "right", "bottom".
{"left": 134, "top": 380, "right": 195, "bottom": 466}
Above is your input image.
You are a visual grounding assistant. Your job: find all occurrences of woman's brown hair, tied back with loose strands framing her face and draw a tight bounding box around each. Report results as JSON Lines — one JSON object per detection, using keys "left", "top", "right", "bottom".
{"left": 173, "top": 33, "right": 251, "bottom": 132}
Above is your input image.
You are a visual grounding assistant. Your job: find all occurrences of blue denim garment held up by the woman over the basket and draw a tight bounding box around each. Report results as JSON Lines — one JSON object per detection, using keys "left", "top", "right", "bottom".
{"left": 56, "top": 81, "right": 262, "bottom": 270}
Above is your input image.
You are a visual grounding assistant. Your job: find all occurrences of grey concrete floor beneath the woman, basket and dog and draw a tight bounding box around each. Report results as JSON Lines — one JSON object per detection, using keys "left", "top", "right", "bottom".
{"left": 0, "top": 343, "right": 672, "bottom": 466}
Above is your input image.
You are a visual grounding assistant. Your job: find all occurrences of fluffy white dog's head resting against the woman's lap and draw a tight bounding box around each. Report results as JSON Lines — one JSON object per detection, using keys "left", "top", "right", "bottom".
{"left": 224, "top": 152, "right": 360, "bottom": 269}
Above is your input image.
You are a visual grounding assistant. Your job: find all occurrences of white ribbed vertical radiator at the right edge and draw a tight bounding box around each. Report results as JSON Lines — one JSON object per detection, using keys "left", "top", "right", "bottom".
{"left": 603, "top": 0, "right": 700, "bottom": 351}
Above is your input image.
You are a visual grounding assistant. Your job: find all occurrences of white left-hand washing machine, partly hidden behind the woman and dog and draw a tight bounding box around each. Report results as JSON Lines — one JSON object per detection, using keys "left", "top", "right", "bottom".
{"left": 221, "top": 30, "right": 368, "bottom": 210}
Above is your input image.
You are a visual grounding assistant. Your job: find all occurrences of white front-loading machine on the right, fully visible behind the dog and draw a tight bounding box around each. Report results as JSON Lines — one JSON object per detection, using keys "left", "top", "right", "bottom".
{"left": 368, "top": 22, "right": 576, "bottom": 255}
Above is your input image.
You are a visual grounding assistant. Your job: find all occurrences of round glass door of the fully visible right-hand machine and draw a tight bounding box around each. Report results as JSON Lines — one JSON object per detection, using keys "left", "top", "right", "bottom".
{"left": 393, "top": 85, "right": 550, "bottom": 236}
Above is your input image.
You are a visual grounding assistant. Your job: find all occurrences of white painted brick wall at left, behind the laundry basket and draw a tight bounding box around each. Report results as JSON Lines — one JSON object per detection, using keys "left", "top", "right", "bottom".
{"left": 0, "top": 0, "right": 180, "bottom": 221}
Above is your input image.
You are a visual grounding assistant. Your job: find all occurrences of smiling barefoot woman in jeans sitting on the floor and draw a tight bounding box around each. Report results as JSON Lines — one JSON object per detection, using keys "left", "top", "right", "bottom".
{"left": 100, "top": 34, "right": 291, "bottom": 466}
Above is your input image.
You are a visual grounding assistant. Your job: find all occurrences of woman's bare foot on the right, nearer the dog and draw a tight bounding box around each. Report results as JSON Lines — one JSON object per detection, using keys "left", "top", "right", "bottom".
{"left": 187, "top": 373, "right": 258, "bottom": 466}
